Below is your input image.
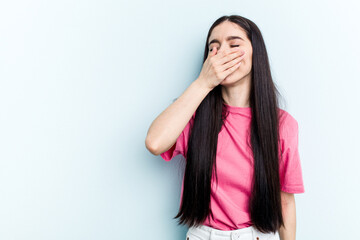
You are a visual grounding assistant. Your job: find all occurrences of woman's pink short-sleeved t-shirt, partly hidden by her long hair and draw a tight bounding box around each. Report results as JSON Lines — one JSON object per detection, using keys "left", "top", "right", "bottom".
{"left": 161, "top": 105, "right": 305, "bottom": 231}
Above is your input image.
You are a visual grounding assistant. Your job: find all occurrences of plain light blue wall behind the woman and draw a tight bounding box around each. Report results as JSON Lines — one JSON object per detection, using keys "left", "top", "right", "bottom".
{"left": 0, "top": 0, "right": 360, "bottom": 240}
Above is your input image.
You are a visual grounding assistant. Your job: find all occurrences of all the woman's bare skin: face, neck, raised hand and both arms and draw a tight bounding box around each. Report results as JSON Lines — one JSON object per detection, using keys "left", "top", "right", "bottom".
{"left": 145, "top": 21, "right": 296, "bottom": 240}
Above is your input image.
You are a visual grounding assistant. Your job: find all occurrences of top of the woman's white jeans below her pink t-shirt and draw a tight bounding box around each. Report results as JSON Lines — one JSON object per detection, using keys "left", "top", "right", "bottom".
{"left": 186, "top": 225, "right": 280, "bottom": 240}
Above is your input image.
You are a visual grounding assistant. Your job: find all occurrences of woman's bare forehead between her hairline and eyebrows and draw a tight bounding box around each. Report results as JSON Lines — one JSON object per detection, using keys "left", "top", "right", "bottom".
{"left": 208, "top": 21, "right": 247, "bottom": 43}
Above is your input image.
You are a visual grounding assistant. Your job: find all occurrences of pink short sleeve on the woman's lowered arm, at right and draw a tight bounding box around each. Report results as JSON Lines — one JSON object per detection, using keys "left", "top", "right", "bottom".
{"left": 279, "top": 112, "right": 305, "bottom": 193}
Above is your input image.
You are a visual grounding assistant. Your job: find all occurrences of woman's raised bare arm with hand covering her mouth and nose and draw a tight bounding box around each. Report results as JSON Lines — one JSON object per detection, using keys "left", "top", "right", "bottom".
{"left": 145, "top": 35, "right": 246, "bottom": 155}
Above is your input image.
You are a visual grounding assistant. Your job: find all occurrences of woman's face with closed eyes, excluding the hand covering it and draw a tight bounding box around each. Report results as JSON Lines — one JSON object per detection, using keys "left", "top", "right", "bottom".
{"left": 208, "top": 21, "right": 252, "bottom": 85}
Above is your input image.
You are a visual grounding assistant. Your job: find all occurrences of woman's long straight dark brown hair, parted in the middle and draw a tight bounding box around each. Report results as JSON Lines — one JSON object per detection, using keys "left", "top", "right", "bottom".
{"left": 174, "top": 15, "right": 284, "bottom": 233}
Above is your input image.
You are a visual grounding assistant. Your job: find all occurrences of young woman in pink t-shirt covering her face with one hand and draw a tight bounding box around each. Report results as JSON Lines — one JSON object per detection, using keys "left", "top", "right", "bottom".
{"left": 145, "top": 15, "right": 305, "bottom": 240}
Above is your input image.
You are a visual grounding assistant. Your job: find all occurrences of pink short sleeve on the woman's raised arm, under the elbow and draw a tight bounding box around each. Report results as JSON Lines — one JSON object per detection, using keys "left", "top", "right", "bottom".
{"left": 160, "top": 113, "right": 195, "bottom": 161}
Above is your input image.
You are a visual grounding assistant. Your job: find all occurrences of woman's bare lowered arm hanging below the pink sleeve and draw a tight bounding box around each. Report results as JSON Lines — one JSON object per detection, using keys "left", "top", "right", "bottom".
{"left": 279, "top": 191, "right": 296, "bottom": 240}
